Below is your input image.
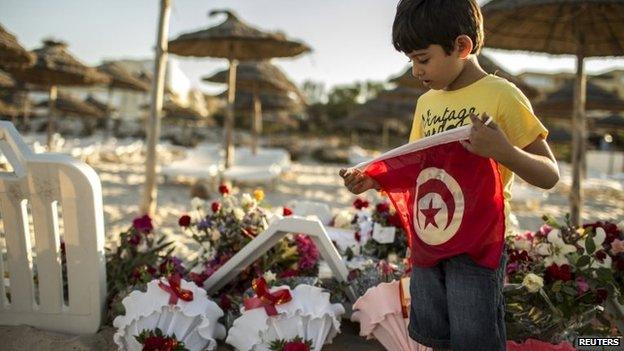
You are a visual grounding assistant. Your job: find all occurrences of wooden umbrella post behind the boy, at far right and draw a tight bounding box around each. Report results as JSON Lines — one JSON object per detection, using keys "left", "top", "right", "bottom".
{"left": 570, "top": 48, "right": 587, "bottom": 226}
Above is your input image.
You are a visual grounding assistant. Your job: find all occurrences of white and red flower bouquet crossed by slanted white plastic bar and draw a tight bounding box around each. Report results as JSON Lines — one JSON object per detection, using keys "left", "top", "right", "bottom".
{"left": 178, "top": 185, "right": 319, "bottom": 310}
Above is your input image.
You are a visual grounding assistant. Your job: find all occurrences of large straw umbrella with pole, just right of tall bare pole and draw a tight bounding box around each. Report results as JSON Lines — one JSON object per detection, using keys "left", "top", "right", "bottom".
{"left": 169, "top": 10, "right": 310, "bottom": 168}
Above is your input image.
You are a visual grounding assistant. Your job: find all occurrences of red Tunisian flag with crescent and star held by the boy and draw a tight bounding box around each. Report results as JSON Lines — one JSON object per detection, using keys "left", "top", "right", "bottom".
{"left": 356, "top": 126, "right": 505, "bottom": 269}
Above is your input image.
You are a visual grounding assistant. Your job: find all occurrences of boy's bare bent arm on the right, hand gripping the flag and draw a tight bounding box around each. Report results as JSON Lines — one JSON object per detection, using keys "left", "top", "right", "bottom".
{"left": 462, "top": 115, "right": 559, "bottom": 189}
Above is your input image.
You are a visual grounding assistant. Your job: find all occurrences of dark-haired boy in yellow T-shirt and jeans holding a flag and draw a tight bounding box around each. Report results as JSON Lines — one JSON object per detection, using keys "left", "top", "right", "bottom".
{"left": 340, "top": 0, "right": 559, "bottom": 351}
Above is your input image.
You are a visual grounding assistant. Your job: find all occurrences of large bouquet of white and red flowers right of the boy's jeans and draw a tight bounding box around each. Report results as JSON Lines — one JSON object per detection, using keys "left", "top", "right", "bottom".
{"left": 506, "top": 217, "right": 624, "bottom": 342}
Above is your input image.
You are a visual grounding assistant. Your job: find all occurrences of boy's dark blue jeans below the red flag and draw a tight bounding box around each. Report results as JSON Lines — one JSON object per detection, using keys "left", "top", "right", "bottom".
{"left": 408, "top": 251, "right": 507, "bottom": 351}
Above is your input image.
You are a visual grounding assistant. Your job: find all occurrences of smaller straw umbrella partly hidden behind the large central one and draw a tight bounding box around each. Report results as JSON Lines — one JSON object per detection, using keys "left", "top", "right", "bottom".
{"left": 203, "top": 61, "right": 302, "bottom": 155}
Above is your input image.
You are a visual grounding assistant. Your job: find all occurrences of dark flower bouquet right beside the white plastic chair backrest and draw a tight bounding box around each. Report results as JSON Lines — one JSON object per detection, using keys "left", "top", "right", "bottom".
{"left": 106, "top": 215, "right": 176, "bottom": 321}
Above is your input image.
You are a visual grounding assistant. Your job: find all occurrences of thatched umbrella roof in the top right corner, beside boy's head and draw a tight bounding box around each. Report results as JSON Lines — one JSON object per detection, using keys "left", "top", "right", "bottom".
{"left": 481, "top": 0, "right": 624, "bottom": 57}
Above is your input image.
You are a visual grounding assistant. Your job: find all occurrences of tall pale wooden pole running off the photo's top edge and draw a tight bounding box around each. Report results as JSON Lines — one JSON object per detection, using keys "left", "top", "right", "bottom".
{"left": 141, "top": 0, "right": 171, "bottom": 215}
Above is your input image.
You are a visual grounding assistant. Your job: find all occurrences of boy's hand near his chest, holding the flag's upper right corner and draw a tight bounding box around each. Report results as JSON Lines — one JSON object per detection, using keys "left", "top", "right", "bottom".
{"left": 460, "top": 112, "right": 513, "bottom": 162}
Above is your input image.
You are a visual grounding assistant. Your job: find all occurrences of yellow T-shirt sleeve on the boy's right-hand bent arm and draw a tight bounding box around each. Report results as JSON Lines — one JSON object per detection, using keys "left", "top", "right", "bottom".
{"left": 497, "top": 85, "right": 548, "bottom": 149}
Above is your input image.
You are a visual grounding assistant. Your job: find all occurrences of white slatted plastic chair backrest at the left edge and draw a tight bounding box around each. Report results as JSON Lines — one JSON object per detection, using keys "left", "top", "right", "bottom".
{"left": 0, "top": 122, "right": 106, "bottom": 334}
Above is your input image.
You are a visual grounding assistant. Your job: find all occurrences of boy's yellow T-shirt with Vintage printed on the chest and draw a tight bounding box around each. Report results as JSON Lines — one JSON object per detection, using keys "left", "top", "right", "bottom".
{"left": 410, "top": 74, "right": 548, "bottom": 234}
